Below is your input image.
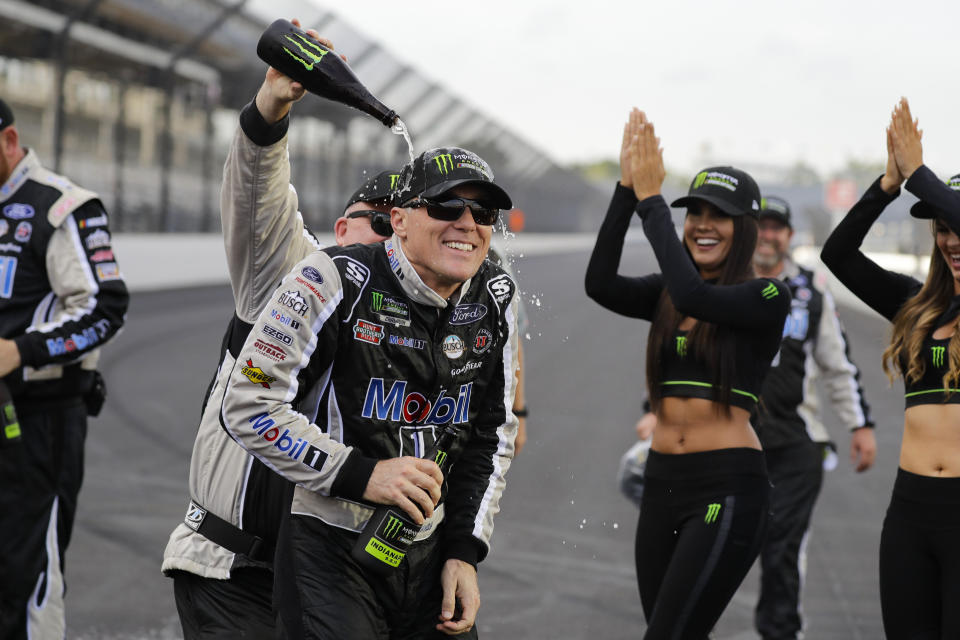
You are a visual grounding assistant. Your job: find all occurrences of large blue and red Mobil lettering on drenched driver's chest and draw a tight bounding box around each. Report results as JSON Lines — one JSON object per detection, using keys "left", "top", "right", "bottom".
{"left": 360, "top": 378, "right": 473, "bottom": 425}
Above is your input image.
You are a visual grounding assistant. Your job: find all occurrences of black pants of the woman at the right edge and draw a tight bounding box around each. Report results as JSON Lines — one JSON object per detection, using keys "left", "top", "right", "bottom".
{"left": 880, "top": 469, "right": 960, "bottom": 640}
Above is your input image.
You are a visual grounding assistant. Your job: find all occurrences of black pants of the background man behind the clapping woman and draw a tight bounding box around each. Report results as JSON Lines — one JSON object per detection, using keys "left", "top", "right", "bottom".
{"left": 754, "top": 442, "right": 823, "bottom": 640}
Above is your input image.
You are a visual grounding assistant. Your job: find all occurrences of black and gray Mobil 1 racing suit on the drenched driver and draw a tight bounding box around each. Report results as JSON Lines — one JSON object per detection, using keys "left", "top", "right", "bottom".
{"left": 214, "top": 236, "right": 517, "bottom": 637}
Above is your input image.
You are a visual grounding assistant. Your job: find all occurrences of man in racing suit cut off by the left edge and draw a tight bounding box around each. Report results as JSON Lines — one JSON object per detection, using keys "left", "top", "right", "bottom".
{"left": 0, "top": 100, "right": 128, "bottom": 640}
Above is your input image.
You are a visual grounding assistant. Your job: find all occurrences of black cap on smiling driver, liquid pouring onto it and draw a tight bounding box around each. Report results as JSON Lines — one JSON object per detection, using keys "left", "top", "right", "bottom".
{"left": 395, "top": 147, "right": 513, "bottom": 209}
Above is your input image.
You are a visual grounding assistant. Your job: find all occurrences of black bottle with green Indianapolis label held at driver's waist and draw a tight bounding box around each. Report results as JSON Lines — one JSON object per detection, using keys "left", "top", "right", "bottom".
{"left": 350, "top": 425, "right": 460, "bottom": 576}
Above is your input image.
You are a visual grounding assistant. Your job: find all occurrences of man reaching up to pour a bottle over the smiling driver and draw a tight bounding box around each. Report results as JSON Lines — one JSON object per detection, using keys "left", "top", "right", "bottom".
{"left": 162, "top": 32, "right": 397, "bottom": 640}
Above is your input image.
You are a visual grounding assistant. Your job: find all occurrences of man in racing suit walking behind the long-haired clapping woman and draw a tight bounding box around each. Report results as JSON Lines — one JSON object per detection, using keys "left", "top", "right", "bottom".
{"left": 754, "top": 197, "right": 876, "bottom": 640}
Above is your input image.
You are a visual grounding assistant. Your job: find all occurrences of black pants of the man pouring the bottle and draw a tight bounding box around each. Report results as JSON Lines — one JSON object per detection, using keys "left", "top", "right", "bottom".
{"left": 170, "top": 567, "right": 281, "bottom": 640}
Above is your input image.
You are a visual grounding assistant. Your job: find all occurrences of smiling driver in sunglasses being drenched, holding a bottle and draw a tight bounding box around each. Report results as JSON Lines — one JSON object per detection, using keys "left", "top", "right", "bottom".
{"left": 220, "top": 148, "right": 517, "bottom": 638}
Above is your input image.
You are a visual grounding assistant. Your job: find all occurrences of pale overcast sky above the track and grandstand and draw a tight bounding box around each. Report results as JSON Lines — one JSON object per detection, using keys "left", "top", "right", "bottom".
{"left": 255, "top": 0, "right": 960, "bottom": 176}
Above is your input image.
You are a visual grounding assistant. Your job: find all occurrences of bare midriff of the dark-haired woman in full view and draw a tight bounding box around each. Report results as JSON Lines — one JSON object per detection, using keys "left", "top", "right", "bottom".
{"left": 651, "top": 396, "right": 760, "bottom": 454}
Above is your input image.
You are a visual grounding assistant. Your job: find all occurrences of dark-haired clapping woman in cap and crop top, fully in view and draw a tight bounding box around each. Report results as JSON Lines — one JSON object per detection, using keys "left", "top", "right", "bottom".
{"left": 586, "top": 109, "right": 790, "bottom": 640}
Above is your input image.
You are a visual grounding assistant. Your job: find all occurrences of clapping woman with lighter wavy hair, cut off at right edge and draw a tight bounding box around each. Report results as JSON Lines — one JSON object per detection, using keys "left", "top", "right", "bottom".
{"left": 821, "top": 99, "right": 960, "bottom": 640}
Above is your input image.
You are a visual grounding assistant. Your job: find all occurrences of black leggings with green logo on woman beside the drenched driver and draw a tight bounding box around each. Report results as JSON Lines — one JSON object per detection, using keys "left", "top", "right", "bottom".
{"left": 636, "top": 448, "right": 770, "bottom": 640}
